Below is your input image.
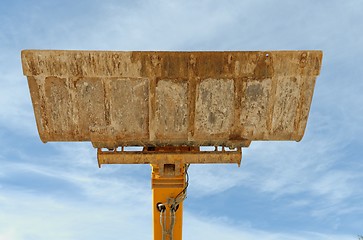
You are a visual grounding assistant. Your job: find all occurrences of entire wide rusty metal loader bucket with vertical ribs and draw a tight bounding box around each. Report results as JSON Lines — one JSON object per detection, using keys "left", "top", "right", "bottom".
{"left": 22, "top": 50, "right": 322, "bottom": 148}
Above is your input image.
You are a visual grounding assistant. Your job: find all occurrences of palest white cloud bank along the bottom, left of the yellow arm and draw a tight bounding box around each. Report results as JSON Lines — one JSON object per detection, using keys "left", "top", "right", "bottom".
{"left": 0, "top": 189, "right": 151, "bottom": 240}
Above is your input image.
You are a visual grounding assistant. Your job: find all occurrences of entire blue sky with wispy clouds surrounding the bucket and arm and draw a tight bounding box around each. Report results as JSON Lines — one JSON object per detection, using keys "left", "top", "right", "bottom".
{"left": 0, "top": 0, "right": 363, "bottom": 240}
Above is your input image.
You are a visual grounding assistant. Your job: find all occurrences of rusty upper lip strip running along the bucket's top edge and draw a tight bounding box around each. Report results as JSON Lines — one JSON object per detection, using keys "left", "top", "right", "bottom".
{"left": 21, "top": 49, "right": 323, "bottom": 78}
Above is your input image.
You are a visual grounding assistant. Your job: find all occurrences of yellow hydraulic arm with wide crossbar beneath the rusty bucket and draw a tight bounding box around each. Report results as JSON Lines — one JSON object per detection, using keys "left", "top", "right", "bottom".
{"left": 97, "top": 146, "right": 242, "bottom": 240}
